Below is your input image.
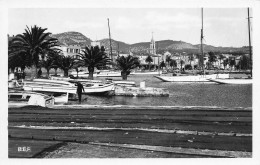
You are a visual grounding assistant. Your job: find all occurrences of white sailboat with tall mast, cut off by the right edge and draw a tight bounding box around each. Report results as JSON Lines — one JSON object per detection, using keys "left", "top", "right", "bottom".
{"left": 208, "top": 8, "right": 253, "bottom": 85}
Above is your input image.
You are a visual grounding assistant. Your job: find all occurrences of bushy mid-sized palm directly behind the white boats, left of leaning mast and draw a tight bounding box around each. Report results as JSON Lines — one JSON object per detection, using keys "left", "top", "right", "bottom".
{"left": 79, "top": 46, "right": 111, "bottom": 79}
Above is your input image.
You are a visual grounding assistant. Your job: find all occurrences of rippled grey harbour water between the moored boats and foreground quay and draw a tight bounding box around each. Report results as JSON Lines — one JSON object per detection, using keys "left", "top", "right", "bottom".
{"left": 69, "top": 75, "right": 252, "bottom": 107}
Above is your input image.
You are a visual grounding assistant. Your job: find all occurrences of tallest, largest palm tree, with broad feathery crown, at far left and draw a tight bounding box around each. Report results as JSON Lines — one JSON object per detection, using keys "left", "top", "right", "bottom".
{"left": 13, "top": 25, "right": 57, "bottom": 77}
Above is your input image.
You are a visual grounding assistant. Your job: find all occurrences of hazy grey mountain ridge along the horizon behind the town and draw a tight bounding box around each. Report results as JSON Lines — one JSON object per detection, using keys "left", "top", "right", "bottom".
{"left": 51, "top": 31, "right": 248, "bottom": 53}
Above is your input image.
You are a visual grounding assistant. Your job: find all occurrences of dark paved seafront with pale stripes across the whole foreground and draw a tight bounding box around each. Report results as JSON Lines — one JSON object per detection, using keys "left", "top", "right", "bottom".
{"left": 8, "top": 105, "right": 252, "bottom": 158}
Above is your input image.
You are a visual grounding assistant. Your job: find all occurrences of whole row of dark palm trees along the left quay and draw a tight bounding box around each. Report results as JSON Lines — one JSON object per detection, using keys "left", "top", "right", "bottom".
{"left": 8, "top": 26, "right": 140, "bottom": 79}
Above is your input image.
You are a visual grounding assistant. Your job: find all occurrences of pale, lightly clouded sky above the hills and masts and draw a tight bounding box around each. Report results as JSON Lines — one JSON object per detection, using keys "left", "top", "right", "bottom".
{"left": 8, "top": 8, "right": 253, "bottom": 47}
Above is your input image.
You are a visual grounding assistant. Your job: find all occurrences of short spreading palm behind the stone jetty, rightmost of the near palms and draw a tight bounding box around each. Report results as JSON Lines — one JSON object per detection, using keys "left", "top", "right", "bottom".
{"left": 116, "top": 55, "right": 140, "bottom": 80}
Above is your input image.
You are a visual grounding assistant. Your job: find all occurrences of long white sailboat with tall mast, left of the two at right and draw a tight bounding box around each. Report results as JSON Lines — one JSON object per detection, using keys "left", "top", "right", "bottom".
{"left": 154, "top": 8, "right": 229, "bottom": 82}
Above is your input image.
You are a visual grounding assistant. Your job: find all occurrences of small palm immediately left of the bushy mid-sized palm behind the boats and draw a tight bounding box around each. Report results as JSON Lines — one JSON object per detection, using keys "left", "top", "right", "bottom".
{"left": 58, "top": 55, "right": 75, "bottom": 77}
